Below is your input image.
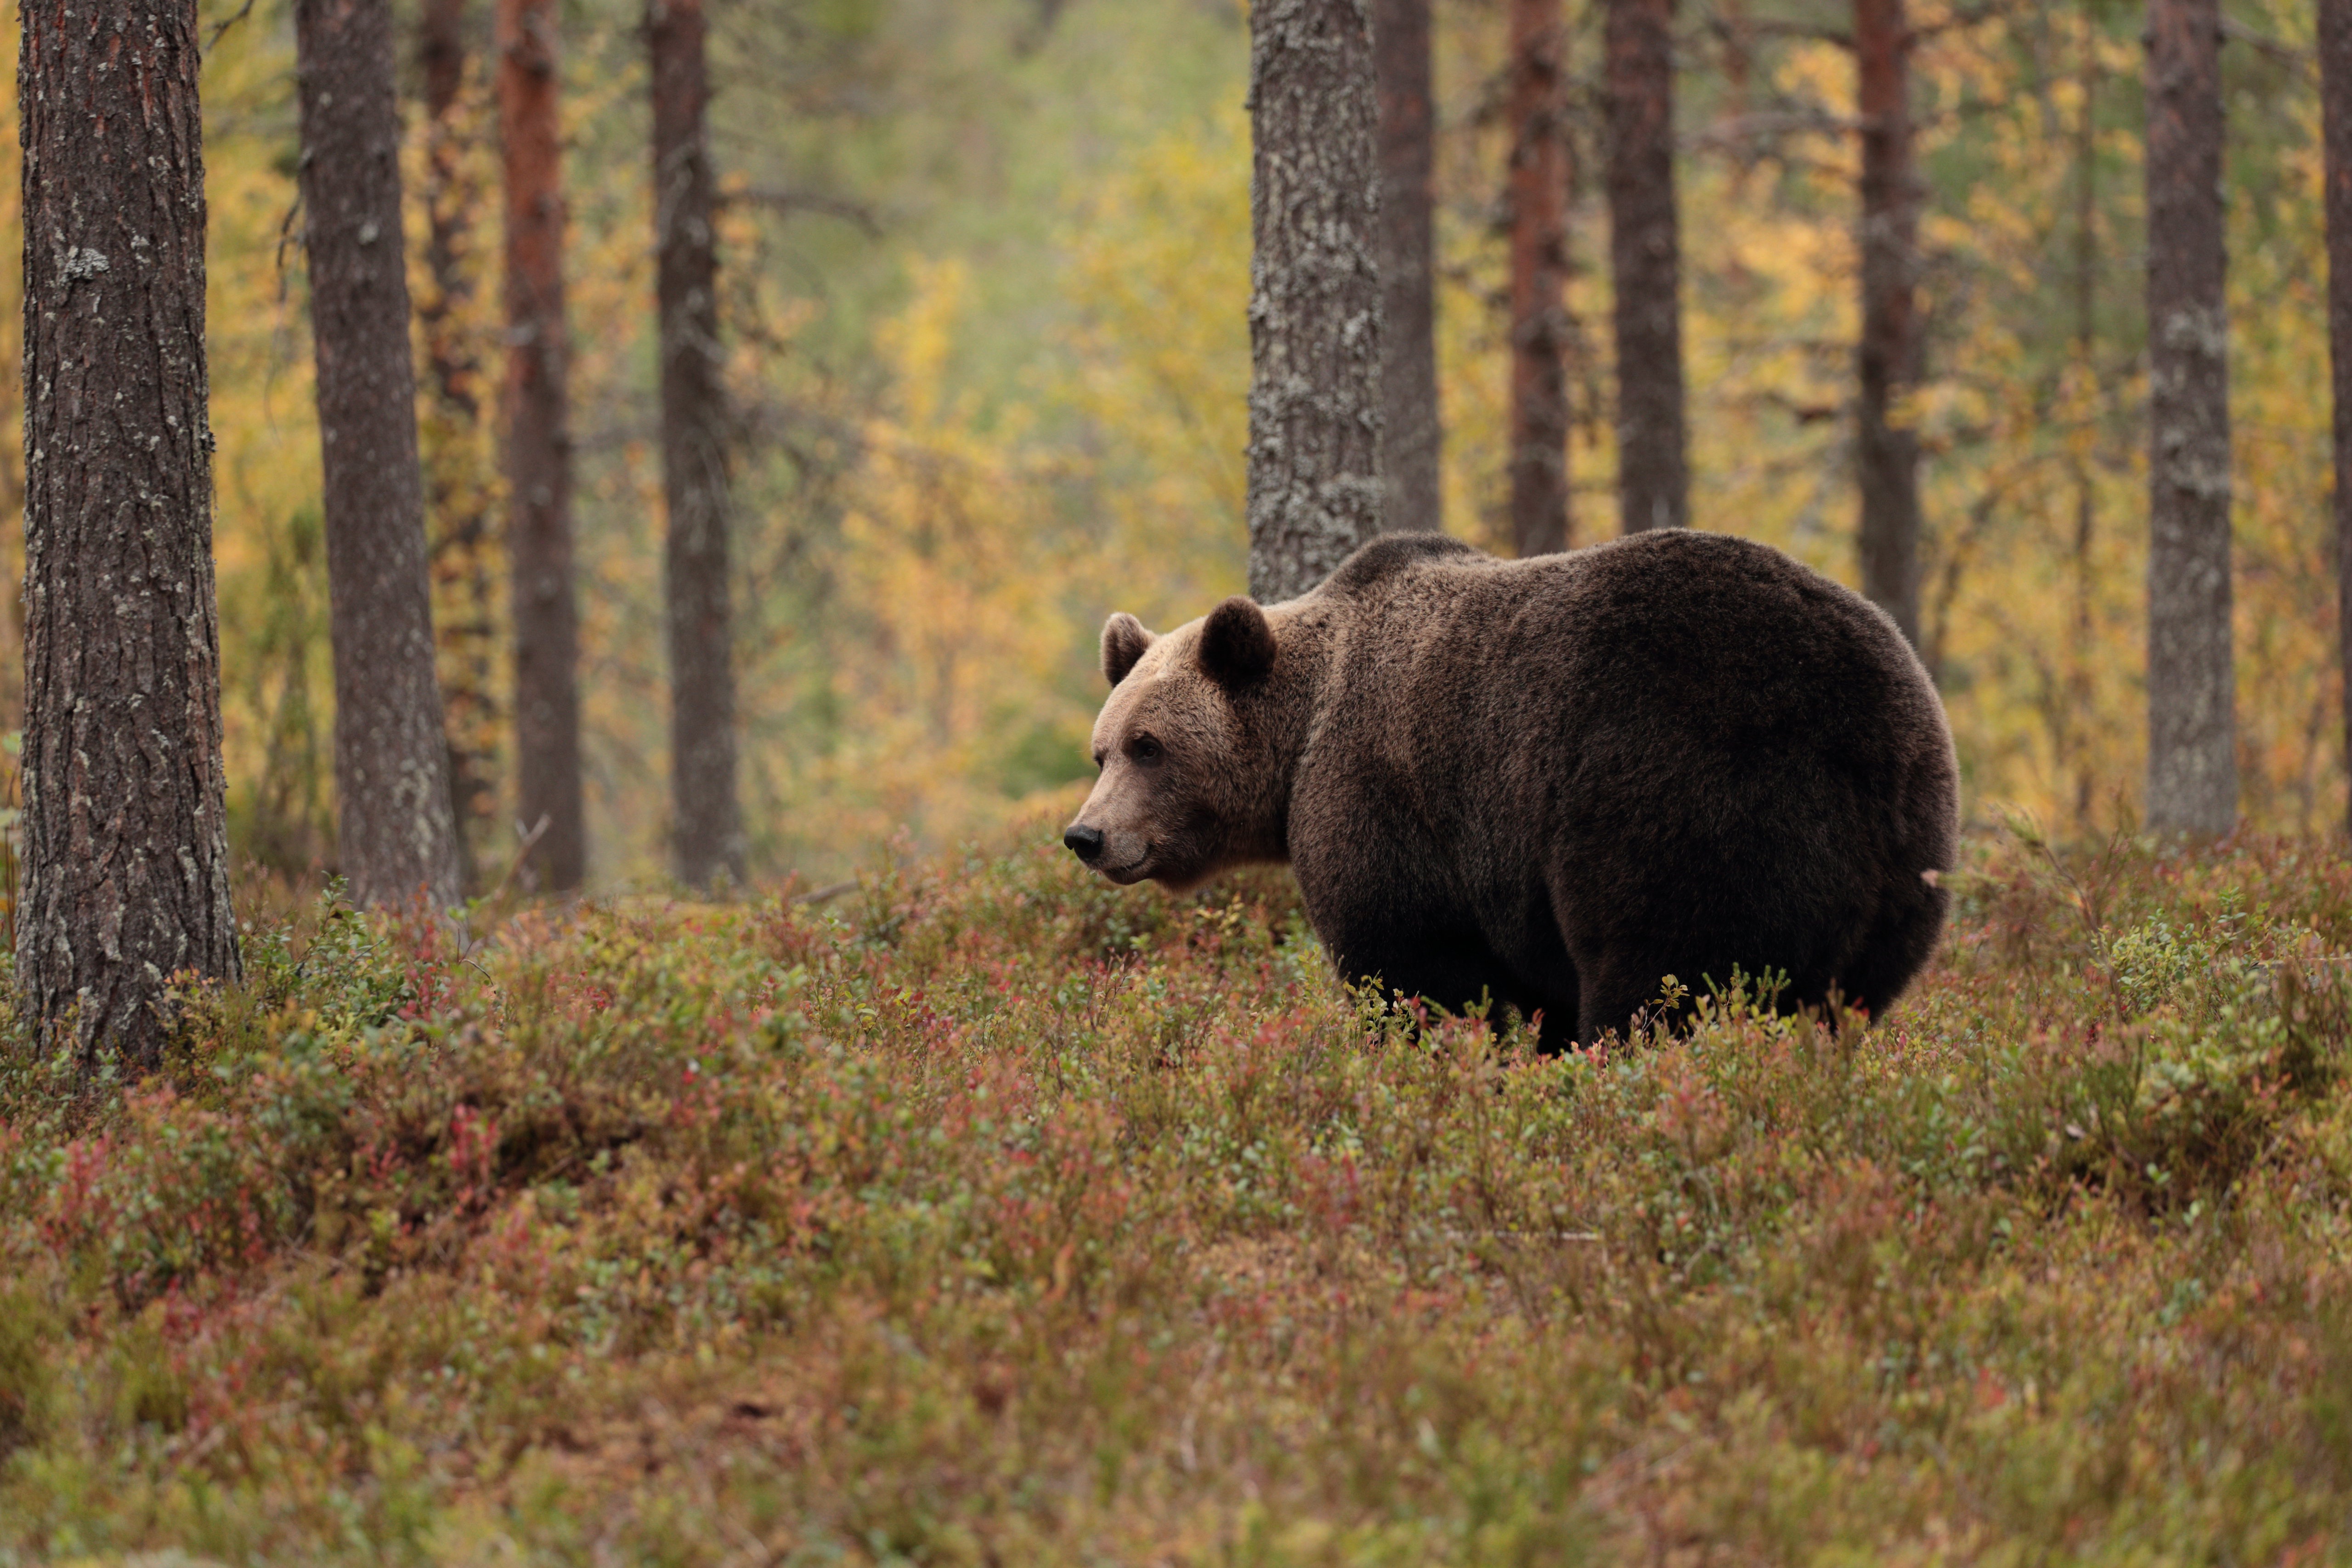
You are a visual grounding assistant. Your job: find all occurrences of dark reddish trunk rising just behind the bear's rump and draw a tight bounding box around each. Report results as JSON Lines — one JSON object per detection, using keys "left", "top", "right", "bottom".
{"left": 1854, "top": 0, "right": 1919, "bottom": 646}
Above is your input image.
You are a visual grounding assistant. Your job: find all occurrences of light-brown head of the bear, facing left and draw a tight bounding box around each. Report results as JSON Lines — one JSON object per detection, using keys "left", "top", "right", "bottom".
{"left": 1061, "top": 600, "right": 1289, "bottom": 893}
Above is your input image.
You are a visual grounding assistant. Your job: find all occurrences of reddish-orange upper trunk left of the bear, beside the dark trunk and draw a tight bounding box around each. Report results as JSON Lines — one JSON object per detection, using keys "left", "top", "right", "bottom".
{"left": 498, "top": 0, "right": 588, "bottom": 891}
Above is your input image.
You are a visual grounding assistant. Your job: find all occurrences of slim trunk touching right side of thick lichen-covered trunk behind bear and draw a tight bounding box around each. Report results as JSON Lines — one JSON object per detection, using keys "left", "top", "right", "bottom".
{"left": 1371, "top": 0, "right": 1444, "bottom": 531}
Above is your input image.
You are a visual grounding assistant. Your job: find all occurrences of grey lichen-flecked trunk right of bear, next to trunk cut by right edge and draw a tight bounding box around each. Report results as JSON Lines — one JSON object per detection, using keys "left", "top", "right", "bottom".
{"left": 2148, "top": 0, "right": 2237, "bottom": 832}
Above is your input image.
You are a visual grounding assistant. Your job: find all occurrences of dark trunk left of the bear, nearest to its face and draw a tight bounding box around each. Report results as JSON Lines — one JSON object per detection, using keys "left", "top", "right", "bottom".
{"left": 645, "top": 0, "right": 743, "bottom": 886}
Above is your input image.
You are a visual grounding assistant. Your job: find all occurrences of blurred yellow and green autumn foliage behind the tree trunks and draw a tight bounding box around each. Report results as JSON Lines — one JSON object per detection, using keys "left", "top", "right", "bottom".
{"left": 0, "top": 0, "right": 2345, "bottom": 886}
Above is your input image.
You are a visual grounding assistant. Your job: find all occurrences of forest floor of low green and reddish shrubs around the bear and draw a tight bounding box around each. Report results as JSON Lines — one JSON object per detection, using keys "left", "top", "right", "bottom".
{"left": 0, "top": 830, "right": 2352, "bottom": 1566}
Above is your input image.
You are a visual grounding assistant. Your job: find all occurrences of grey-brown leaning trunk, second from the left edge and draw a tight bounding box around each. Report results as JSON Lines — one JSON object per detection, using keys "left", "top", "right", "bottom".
{"left": 294, "top": 0, "right": 461, "bottom": 910}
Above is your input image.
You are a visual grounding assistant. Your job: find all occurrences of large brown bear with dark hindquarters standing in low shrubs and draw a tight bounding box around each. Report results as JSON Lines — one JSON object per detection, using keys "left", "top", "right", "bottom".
{"left": 1063, "top": 529, "right": 1959, "bottom": 1048}
